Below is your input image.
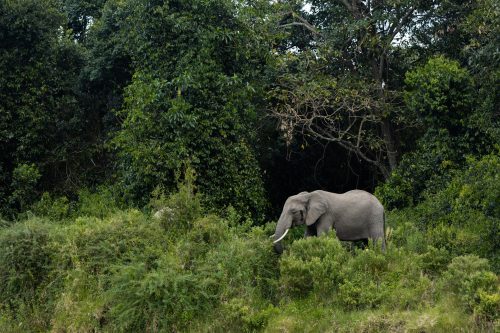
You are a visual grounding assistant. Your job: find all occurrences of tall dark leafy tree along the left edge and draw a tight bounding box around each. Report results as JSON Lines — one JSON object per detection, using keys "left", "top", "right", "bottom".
{"left": 0, "top": 0, "right": 84, "bottom": 214}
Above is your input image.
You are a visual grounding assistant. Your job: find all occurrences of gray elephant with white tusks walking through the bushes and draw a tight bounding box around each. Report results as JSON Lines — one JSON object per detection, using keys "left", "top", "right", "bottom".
{"left": 271, "top": 190, "right": 385, "bottom": 253}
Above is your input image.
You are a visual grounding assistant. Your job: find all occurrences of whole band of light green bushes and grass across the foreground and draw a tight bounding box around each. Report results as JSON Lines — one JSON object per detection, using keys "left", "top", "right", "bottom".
{"left": 0, "top": 155, "right": 500, "bottom": 332}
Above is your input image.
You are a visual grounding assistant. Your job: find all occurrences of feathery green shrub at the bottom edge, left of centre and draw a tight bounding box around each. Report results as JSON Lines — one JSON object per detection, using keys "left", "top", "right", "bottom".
{"left": 107, "top": 253, "right": 214, "bottom": 332}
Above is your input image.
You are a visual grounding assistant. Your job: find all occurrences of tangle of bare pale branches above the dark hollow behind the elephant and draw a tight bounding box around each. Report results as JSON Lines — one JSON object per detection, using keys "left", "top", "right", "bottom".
{"left": 271, "top": 75, "right": 389, "bottom": 177}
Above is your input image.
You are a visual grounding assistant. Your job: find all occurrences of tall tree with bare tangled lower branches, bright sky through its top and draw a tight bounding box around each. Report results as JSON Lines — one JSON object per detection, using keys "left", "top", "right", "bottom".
{"left": 272, "top": 0, "right": 484, "bottom": 177}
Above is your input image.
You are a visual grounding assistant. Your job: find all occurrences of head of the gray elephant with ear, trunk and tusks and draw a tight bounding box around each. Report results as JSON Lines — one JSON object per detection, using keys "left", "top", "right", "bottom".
{"left": 271, "top": 192, "right": 327, "bottom": 253}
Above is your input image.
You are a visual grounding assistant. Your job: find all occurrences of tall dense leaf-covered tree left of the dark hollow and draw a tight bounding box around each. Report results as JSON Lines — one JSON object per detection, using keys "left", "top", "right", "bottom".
{"left": 113, "top": 1, "right": 272, "bottom": 218}
